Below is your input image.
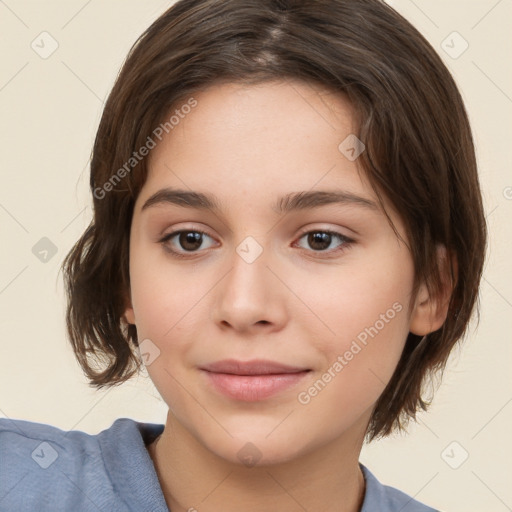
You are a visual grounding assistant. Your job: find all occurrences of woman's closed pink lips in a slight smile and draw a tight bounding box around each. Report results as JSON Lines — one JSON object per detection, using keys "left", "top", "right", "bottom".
{"left": 201, "top": 359, "right": 310, "bottom": 402}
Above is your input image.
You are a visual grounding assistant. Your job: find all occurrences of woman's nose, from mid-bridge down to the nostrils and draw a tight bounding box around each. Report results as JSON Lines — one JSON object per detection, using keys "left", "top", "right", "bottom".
{"left": 212, "top": 237, "right": 290, "bottom": 333}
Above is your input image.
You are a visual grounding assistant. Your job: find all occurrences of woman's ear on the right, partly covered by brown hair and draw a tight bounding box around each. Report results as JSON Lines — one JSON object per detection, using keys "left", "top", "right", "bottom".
{"left": 409, "top": 245, "right": 457, "bottom": 336}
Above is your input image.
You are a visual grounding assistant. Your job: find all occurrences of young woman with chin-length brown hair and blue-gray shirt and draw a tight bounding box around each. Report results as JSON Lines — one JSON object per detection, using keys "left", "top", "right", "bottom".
{"left": 0, "top": 0, "right": 486, "bottom": 512}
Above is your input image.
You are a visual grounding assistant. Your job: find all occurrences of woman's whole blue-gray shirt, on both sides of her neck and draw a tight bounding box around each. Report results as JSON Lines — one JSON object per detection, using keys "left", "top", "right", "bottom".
{"left": 0, "top": 418, "right": 436, "bottom": 512}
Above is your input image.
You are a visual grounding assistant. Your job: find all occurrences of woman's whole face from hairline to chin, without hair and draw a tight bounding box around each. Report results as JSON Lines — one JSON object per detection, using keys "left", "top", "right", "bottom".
{"left": 125, "top": 82, "right": 430, "bottom": 463}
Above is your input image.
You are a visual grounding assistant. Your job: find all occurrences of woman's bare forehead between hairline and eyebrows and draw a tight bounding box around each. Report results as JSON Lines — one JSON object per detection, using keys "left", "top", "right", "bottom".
{"left": 142, "top": 81, "right": 368, "bottom": 198}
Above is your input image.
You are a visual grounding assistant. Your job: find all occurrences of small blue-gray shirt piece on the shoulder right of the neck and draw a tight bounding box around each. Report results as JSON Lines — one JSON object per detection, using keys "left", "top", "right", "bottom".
{"left": 359, "top": 464, "right": 439, "bottom": 512}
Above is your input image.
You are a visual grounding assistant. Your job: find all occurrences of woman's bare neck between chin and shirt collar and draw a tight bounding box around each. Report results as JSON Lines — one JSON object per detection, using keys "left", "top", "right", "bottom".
{"left": 148, "top": 412, "right": 365, "bottom": 512}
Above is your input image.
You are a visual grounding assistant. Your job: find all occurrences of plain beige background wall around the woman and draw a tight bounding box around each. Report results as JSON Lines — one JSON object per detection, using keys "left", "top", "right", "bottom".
{"left": 0, "top": 0, "right": 512, "bottom": 512}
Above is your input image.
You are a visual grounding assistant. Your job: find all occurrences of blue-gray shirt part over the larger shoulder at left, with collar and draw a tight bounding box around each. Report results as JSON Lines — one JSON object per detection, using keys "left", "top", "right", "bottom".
{"left": 0, "top": 418, "right": 160, "bottom": 512}
